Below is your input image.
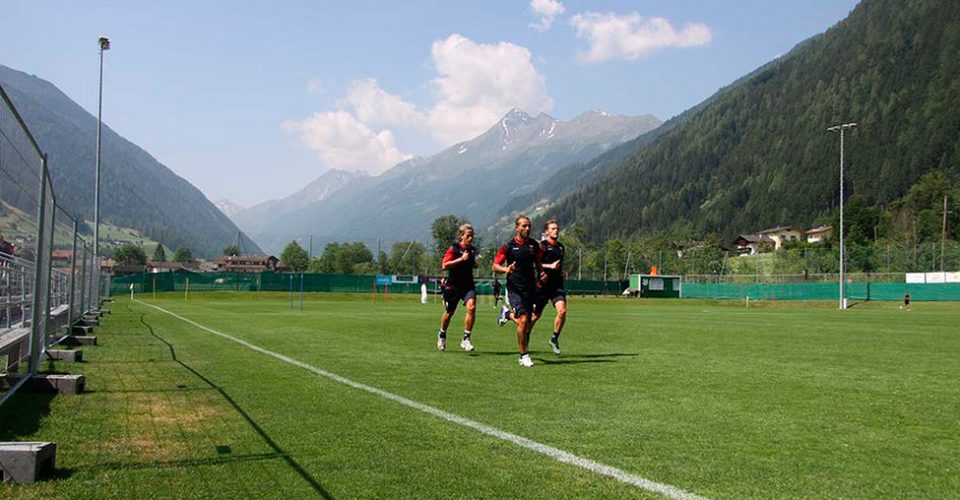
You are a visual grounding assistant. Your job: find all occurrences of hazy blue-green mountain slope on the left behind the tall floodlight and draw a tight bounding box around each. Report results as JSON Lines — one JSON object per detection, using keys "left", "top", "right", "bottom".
{"left": 0, "top": 65, "right": 260, "bottom": 257}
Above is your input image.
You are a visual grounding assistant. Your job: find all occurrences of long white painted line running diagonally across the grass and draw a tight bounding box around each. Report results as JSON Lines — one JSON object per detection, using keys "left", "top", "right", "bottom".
{"left": 136, "top": 300, "right": 705, "bottom": 500}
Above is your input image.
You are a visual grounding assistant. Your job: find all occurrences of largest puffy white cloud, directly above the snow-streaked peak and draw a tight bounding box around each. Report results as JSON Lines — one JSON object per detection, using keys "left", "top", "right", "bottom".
{"left": 427, "top": 34, "right": 553, "bottom": 146}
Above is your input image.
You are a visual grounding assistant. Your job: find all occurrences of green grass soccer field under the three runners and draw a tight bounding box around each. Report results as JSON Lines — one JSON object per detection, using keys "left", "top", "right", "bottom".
{"left": 0, "top": 293, "right": 960, "bottom": 498}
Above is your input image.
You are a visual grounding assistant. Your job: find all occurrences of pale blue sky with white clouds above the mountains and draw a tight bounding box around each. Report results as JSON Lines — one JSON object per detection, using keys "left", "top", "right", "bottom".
{"left": 0, "top": 0, "right": 857, "bottom": 206}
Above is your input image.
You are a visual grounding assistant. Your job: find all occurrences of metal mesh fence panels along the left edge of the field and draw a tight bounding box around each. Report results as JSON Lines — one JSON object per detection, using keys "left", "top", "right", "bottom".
{"left": 0, "top": 87, "right": 101, "bottom": 404}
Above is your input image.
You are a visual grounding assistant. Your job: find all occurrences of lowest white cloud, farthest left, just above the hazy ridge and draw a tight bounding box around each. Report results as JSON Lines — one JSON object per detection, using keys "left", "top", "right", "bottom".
{"left": 283, "top": 111, "right": 411, "bottom": 175}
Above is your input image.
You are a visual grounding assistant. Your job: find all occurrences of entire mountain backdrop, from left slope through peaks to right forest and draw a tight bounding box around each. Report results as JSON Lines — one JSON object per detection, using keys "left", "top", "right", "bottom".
{"left": 0, "top": 0, "right": 960, "bottom": 262}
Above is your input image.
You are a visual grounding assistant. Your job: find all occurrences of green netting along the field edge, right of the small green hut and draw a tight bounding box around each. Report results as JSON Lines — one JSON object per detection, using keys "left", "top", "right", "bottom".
{"left": 683, "top": 283, "right": 960, "bottom": 301}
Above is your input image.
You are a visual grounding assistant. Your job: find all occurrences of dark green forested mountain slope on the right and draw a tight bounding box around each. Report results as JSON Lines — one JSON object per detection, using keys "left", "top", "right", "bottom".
{"left": 540, "top": 0, "right": 960, "bottom": 241}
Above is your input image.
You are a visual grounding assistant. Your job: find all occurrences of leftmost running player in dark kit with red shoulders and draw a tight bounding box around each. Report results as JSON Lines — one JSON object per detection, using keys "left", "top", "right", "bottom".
{"left": 437, "top": 224, "right": 477, "bottom": 352}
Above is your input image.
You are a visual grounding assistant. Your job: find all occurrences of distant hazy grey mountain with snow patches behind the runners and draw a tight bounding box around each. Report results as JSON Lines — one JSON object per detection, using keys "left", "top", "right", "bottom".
{"left": 234, "top": 109, "right": 660, "bottom": 250}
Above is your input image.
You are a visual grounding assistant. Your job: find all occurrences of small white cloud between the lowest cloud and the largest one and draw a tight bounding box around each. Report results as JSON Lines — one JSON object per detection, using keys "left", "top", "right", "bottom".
{"left": 338, "top": 78, "right": 426, "bottom": 127}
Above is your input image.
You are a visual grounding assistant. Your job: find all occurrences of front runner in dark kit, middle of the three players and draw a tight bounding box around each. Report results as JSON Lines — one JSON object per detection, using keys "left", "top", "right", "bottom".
{"left": 493, "top": 215, "right": 543, "bottom": 368}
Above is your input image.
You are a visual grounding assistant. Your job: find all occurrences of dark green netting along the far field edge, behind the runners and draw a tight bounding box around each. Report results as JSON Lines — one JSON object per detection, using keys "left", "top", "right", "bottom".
{"left": 110, "top": 272, "right": 625, "bottom": 295}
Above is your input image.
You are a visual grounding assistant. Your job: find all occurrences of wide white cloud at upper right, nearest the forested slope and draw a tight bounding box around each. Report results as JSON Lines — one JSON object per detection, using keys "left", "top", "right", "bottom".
{"left": 570, "top": 12, "right": 712, "bottom": 63}
